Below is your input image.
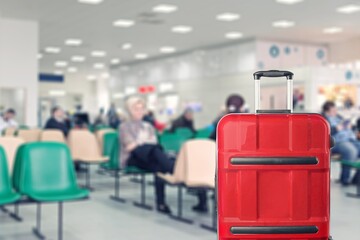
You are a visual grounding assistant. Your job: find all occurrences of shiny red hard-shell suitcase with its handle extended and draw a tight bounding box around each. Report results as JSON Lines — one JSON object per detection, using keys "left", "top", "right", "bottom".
{"left": 217, "top": 70, "right": 331, "bottom": 240}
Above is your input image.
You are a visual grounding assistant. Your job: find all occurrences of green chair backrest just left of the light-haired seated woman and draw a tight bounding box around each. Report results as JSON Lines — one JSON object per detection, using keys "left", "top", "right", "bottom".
{"left": 102, "top": 131, "right": 120, "bottom": 169}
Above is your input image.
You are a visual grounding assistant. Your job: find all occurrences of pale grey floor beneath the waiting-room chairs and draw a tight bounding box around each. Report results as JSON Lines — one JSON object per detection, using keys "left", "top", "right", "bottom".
{"left": 0, "top": 164, "right": 360, "bottom": 240}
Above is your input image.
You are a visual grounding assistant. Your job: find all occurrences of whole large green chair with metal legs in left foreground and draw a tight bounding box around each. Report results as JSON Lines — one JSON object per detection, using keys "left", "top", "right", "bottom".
{"left": 14, "top": 142, "right": 89, "bottom": 240}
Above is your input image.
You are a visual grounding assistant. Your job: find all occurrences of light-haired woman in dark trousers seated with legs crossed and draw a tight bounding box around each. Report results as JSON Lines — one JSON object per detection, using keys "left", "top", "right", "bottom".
{"left": 120, "top": 97, "right": 174, "bottom": 214}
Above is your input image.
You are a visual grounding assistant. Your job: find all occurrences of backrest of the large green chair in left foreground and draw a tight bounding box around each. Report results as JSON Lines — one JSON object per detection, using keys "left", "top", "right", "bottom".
{"left": 17, "top": 142, "right": 77, "bottom": 196}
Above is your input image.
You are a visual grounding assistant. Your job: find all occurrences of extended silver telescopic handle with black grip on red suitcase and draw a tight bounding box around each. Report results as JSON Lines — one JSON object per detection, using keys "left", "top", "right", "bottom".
{"left": 254, "top": 70, "right": 294, "bottom": 113}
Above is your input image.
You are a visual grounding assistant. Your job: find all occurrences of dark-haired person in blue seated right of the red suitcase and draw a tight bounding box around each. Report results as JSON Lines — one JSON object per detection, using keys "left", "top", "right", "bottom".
{"left": 322, "top": 101, "right": 360, "bottom": 186}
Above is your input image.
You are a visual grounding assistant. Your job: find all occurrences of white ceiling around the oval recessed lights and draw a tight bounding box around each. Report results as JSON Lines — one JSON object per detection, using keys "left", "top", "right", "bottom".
{"left": 0, "top": 0, "right": 360, "bottom": 77}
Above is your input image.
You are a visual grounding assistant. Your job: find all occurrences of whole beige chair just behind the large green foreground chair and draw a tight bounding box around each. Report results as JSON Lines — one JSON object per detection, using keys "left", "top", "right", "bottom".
{"left": 68, "top": 129, "right": 109, "bottom": 190}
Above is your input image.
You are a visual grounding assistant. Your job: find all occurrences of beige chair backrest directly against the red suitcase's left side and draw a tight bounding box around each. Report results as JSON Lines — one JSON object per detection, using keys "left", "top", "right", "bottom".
{"left": 184, "top": 139, "right": 216, "bottom": 187}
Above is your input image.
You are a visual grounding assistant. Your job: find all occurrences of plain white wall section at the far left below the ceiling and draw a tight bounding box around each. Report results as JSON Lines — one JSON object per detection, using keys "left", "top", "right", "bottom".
{"left": 0, "top": 18, "right": 38, "bottom": 126}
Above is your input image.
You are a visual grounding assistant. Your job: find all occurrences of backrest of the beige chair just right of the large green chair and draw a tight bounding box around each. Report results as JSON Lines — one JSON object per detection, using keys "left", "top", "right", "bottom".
{"left": 68, "top": 129, "right": 102, "bottom": 160}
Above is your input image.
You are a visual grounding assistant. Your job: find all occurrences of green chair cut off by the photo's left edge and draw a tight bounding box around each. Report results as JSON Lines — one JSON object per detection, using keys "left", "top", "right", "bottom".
{"left": 0, "top": 146, "right": 20, "bottom": 206}
